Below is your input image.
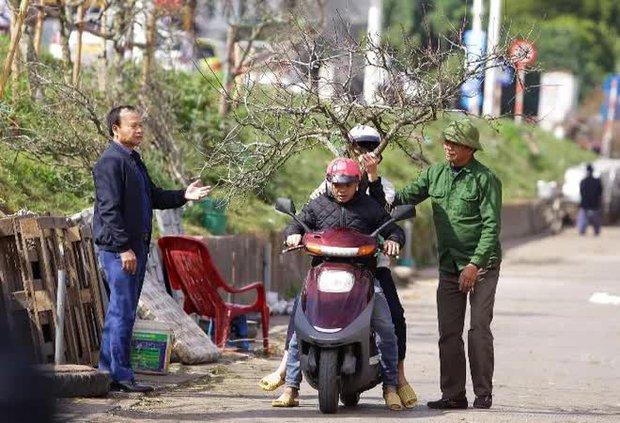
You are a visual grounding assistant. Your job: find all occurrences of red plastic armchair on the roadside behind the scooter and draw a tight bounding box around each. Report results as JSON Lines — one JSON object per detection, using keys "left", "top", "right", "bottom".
{"left": 158, "top": 236, "right": 269, "bottom": 349}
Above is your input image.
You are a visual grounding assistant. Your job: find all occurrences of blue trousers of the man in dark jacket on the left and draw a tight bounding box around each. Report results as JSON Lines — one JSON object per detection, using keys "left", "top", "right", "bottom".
{"left": 99, "top": 250, "right": 146, "bottom": 382}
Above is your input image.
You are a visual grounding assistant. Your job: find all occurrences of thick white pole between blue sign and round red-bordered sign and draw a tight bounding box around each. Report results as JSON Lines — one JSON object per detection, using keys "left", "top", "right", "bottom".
{"left": 482, "top": 0, "right": 502, "bottom": 116}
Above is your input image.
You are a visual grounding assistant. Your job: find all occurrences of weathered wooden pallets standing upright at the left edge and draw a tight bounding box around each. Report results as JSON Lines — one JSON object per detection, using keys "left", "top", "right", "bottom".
{"left": 0, "top": 216, "right": 104, "bottom": 365}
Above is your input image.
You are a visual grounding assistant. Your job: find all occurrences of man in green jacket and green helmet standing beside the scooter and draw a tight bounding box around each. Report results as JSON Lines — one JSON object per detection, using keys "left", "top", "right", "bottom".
{"left": 366, "top": 118, "right": 502, "bottom": 409}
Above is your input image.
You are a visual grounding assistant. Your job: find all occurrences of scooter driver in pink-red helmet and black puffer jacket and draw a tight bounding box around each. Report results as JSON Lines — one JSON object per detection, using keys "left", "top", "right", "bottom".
{"left": 272, "top": 158, "right": 405, "bottom": 410}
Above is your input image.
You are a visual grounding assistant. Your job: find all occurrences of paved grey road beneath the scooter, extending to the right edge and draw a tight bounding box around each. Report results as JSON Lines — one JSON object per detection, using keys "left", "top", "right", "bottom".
{"left": 59, "top": 227, "right": 620, "bottom": 422}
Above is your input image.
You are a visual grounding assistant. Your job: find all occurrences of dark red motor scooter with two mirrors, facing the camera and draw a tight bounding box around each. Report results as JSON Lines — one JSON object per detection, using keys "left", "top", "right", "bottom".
{"left": 275, "top": 198, "right": 415, "bottom": 413}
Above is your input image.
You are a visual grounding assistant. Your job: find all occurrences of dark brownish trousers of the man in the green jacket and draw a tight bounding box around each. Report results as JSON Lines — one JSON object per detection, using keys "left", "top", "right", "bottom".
{"left": 437, "top": 267, "right": 499, "bottom": 398}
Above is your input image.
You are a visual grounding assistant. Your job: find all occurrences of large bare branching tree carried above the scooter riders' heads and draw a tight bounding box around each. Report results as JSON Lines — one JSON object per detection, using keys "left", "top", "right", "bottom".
{"left": 205, "top": 14, "right": 512, "bottom": 198}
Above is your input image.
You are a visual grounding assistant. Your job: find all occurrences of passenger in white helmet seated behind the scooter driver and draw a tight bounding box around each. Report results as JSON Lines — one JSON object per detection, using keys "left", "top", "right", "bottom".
{"left": 259, "top": 125, "right": 418, "bottom": 408}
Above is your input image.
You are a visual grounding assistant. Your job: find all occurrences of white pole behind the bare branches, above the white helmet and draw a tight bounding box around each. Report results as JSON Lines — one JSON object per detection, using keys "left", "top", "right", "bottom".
{"left": 364, "top": 0, "right": 383, "bottom": 104}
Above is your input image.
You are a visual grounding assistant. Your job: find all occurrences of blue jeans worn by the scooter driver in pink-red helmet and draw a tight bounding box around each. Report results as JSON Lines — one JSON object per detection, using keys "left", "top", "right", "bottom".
{"left": 285, "top": 282, "right": 398, "bottom": 389}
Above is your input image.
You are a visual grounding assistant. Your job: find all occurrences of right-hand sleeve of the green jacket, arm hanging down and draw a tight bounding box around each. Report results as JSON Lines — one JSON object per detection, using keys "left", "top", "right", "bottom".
{"left": 470, "top": 175, "right": 502, "bottom": 268}
